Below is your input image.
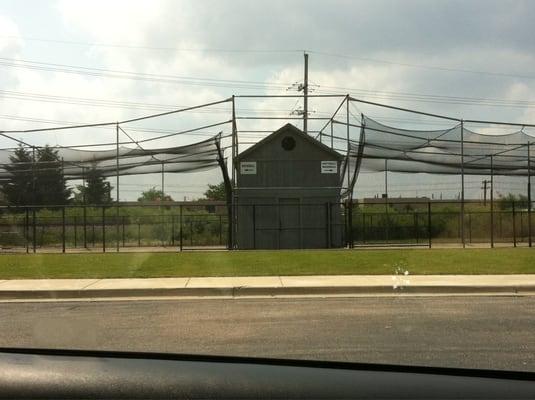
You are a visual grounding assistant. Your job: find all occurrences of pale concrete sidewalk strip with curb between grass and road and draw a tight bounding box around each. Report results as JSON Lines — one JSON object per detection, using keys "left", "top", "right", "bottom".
{"left": 0, "top": 275, "right": 535, "bottom": 300}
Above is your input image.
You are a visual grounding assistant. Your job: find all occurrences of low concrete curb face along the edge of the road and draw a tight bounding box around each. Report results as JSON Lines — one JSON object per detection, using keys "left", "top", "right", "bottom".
{"left": 0, "top": 285, "right": 535, "bottom": 300}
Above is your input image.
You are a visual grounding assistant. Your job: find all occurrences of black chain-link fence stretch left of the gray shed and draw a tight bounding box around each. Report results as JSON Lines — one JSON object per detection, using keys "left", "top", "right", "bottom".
{"left": 0, "top": 204, "right": 229, "bottom": 252}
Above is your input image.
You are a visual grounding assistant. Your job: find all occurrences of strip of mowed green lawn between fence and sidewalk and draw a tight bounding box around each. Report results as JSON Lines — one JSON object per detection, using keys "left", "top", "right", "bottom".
{"left": 0, "top": 248, "right": 535, "bottom": 279}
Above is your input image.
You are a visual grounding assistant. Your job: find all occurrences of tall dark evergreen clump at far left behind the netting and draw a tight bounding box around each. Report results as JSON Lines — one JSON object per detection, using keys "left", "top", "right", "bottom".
{"left": 2, "top": 145, "right": 71, "bottom": 205}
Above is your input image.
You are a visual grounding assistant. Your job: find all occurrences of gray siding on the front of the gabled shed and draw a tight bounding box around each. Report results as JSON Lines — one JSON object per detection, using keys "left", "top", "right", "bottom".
{"left": 236, "top": 125, "right": 343, "bottom": 249}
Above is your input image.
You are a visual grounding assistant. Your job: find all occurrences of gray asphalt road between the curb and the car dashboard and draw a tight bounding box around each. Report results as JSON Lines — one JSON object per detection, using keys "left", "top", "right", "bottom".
{"left": 0, "top": 297, "right": 535, "bottom": 371}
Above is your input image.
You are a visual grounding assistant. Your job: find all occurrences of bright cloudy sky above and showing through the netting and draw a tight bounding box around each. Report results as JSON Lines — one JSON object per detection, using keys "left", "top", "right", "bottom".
{"left": 0, "top": 0, "right": 535, "bottom": 199}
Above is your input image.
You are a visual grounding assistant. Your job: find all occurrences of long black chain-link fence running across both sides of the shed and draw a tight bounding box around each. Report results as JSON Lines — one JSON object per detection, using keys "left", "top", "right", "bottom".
{"left": 0, "top": 199, "right": 535, "bottom": 253}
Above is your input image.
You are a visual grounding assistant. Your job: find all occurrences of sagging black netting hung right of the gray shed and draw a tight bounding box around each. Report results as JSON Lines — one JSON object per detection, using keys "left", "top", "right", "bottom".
{"left": 350, "top": 116, "right": 535, "bottom": 176}
